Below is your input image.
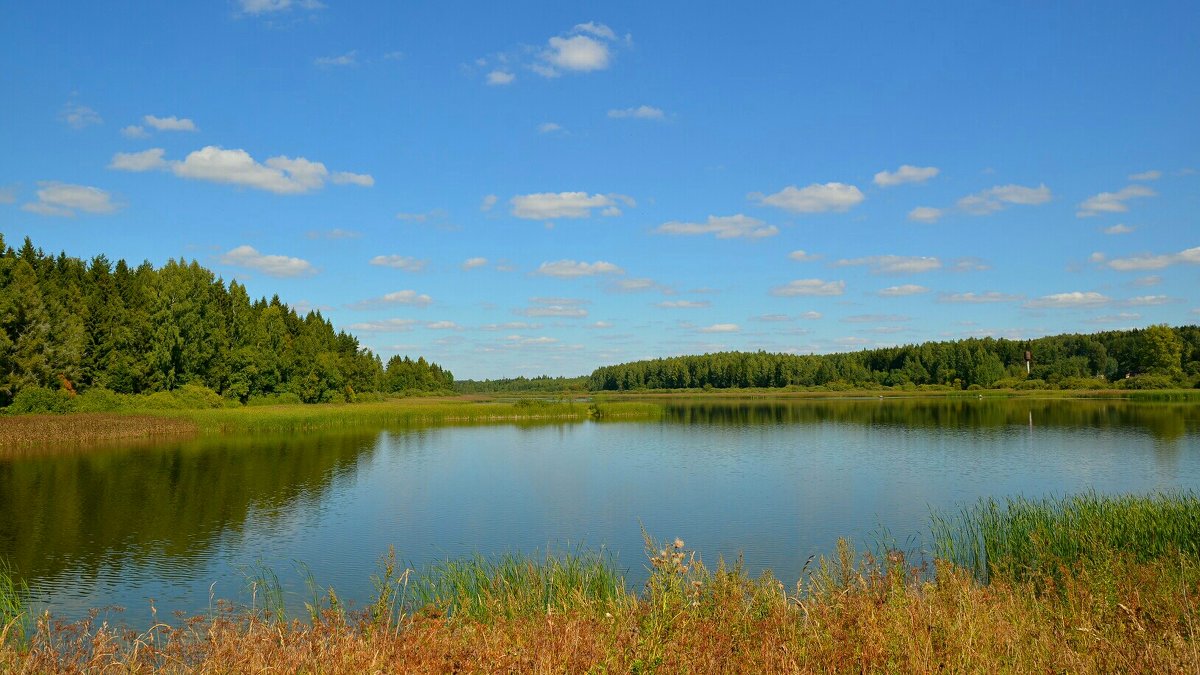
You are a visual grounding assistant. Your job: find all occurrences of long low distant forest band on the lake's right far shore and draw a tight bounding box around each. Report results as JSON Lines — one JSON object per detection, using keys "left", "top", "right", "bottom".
{"left": 589, "top": 325, "right": 1200, "bottom": 392}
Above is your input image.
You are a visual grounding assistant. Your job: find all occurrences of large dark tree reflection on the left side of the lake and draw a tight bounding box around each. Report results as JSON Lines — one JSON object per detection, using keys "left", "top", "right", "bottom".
{"left": 0, "top": 432, "right": 376, "bottom": 578}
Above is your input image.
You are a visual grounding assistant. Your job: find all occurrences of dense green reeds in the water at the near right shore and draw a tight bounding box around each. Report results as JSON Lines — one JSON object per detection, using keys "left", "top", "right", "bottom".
{"left": 932, "top": 491, "right": 1200, "bottom": 581}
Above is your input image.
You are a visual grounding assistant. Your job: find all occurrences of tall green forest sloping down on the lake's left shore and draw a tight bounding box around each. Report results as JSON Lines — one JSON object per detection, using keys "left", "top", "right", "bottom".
{"left": 0, "top": 234, "right": 454, "bottom": 407}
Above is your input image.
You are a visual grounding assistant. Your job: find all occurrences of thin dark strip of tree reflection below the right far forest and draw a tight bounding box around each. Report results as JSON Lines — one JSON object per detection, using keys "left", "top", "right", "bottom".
{"left": 664, "top": 399, "right": 1200, "bottom": 442}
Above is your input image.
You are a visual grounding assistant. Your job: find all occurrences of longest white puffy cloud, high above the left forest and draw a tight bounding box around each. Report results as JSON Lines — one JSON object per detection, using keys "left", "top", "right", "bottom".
{"left": 108, "top": 145, "right": 374, "bottom": 195}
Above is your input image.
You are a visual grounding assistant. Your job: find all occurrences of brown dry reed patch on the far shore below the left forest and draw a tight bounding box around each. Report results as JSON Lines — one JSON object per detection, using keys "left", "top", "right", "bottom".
{"left": 0, "top": 412, "right": 197, "bottom": 454}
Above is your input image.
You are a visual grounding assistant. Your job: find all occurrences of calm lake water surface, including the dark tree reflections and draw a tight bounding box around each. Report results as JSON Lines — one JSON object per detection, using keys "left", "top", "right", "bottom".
{"left": 0, "top": 400, "right": 1200, "bottom": 625}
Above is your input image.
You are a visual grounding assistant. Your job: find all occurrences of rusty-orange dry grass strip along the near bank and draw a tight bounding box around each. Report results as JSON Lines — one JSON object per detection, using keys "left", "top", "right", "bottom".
{"left": 0, "top": 533, "right": 1200, "bottom": 674}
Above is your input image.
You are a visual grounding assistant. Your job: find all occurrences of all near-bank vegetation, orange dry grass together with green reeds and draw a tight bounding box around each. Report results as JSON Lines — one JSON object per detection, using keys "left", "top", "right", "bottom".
{"left": 0, "top": 494, "right": 1200, "bottom": 673}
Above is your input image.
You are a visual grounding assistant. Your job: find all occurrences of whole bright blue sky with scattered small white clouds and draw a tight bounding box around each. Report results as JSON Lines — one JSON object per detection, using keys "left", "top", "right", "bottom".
{"left": 0, "top": 0, "right": 1200, "bottom": 377}
